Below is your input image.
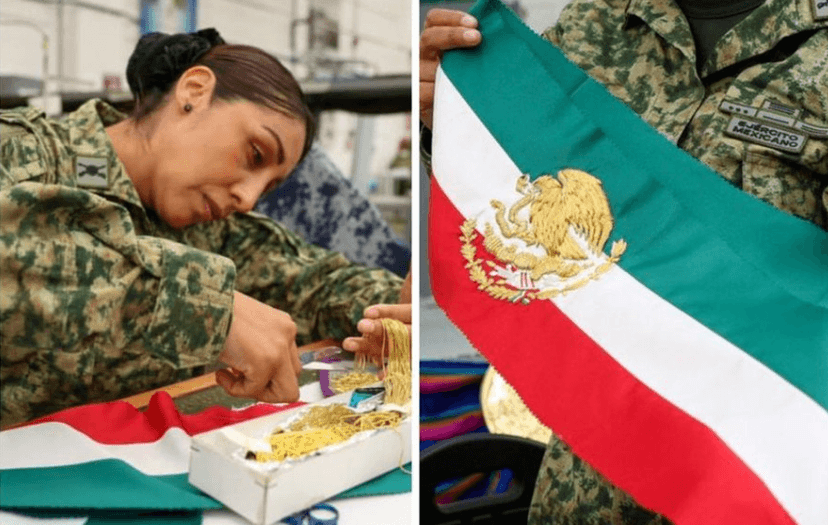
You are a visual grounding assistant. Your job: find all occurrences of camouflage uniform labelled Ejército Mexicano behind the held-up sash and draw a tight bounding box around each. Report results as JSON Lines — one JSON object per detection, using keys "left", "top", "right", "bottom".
{"left": 529, "top": 0, "right": 828, "bottom": 525}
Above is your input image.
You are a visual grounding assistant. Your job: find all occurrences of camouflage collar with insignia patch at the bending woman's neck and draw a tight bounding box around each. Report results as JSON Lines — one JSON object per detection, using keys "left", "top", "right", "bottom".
{"left": 64, "top": 99, "right": 150, "bottom": 216}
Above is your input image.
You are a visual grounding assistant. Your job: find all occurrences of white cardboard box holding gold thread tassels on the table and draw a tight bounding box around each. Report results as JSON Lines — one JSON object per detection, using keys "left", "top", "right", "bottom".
{"left": 189, "top": 392, "right": 411, "bottom": 525}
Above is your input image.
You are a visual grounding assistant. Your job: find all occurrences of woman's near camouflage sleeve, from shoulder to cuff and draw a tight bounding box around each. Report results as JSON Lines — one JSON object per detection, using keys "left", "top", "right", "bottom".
{"left": 0, "top": 113, "right": 235, "bottom": 372}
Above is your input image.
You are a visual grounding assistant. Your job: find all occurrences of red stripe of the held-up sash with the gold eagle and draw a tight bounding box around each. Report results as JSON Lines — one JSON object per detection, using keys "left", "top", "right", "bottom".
{"left": 429, "top": 177, "right": 794, "bottom": 525}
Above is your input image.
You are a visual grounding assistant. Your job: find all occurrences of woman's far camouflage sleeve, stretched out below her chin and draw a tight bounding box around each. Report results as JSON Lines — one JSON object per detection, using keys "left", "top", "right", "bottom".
{"left": 173, "top": 213, "right": 402, "bottom": 345}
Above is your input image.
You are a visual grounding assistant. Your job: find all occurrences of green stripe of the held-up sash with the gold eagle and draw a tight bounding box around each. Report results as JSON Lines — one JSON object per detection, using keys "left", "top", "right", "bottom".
{"left": 442, "top": 0, "right": 828, "bottom": 409}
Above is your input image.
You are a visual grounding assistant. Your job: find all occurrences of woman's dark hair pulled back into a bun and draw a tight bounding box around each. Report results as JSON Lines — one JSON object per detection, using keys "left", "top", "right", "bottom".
{"left": 126, "top": 28, "right": 315, "bottom": 162}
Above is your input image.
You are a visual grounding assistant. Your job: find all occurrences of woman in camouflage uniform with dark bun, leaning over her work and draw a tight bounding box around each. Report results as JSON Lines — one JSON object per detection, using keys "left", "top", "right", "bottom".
{"left": 0, "top": 30, "right": 401, "bottom": 426}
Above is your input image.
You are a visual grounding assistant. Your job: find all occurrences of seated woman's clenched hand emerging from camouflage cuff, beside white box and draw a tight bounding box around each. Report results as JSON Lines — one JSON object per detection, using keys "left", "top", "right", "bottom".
{"left": 216, "top": 292, "right": 302, "bottom": 403}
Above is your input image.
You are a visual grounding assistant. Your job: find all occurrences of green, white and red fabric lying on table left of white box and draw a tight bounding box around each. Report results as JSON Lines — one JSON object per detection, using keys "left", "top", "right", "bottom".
{"left": 0, "top": 392, "right": 298, "bottom": 524}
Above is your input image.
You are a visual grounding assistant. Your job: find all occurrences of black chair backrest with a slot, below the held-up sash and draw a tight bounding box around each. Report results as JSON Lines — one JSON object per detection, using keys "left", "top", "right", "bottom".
{"left": 420, "top": 434, "right": 546, "bottom": 525}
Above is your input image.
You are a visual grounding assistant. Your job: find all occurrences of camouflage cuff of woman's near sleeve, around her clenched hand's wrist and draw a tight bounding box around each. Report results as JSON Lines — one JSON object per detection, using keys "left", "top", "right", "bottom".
{"left": 144, "top": 237, "right": 236, "bottom": 368}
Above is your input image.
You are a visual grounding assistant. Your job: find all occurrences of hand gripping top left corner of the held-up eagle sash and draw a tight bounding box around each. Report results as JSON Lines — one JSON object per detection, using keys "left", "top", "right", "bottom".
{"left": 420, "top": 9, "right": 480, "bottom": 129}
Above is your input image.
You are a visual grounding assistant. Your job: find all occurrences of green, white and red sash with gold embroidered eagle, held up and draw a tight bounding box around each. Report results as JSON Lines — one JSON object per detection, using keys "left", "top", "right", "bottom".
{"left": 429, "top": 0, "right": 828, "bottom": 525}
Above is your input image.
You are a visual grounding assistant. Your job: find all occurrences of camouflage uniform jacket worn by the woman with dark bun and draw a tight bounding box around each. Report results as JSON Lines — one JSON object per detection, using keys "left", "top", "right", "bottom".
{"left": 0, "top": 101, "right": 401, "bottom": 425}
